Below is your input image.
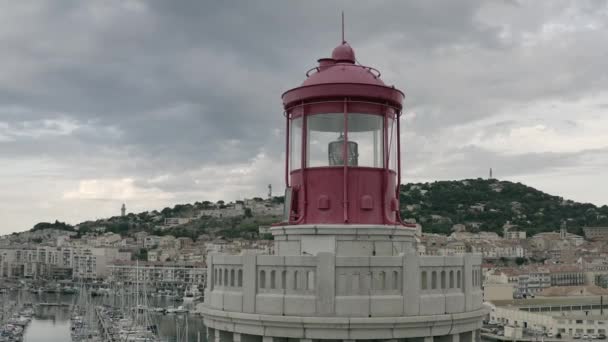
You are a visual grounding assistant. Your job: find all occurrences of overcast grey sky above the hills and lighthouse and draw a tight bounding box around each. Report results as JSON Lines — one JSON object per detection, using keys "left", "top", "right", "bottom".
{"left": 0, "top": 0, "right": 608, "bottom": 233}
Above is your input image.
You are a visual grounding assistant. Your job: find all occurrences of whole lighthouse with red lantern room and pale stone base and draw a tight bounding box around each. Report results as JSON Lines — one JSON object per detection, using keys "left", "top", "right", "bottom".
{"left": 197, "top": 37, "right": 487, "bottom": 342}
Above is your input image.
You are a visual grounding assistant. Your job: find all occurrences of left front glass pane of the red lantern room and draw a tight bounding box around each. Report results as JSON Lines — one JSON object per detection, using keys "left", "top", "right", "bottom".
{"left": 306, "top": 113, "right": 344, "bottom": 167}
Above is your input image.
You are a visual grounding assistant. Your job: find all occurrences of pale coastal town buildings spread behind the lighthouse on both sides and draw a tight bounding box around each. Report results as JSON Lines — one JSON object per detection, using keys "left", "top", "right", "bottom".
{"left": 0, "top": 192, "right": 608, "bottom": 339}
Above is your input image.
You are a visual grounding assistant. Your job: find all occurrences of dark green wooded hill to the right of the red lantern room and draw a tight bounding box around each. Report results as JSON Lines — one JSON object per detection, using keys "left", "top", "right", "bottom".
{"left": 400, "top": 178, "right": 608, "bottom": 236}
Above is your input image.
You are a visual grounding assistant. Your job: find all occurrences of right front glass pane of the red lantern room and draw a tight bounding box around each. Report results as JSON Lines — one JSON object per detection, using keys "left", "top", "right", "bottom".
{"left": 348, "top": 113, "right": 383, "bottom": 167}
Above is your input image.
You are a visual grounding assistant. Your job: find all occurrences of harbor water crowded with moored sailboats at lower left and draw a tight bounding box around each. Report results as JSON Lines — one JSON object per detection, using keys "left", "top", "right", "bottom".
{"left": 0, "top": 290, "right": 206, "bottom": 342}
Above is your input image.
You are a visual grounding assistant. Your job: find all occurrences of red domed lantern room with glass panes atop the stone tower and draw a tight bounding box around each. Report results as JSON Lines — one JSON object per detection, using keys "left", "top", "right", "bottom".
{"left": 282, "top": 42, "right": 404, "bottom": 225}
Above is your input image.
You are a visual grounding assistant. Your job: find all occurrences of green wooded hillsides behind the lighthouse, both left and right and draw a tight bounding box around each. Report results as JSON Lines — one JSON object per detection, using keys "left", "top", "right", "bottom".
{"left": 26, "top": 179, "right": 608, "bottom": 239}
